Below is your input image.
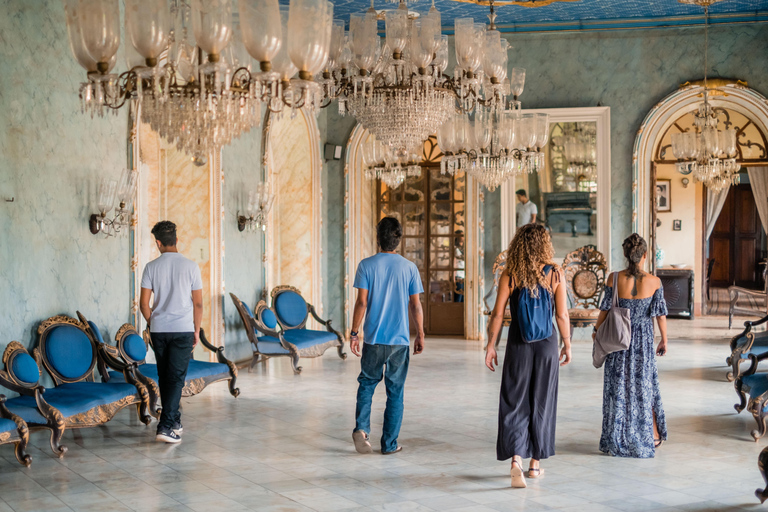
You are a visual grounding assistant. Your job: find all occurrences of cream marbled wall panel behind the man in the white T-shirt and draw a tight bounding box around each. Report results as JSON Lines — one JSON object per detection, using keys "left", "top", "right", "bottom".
{"left": 132, "top": 110, "right": 224, "bottom": 360}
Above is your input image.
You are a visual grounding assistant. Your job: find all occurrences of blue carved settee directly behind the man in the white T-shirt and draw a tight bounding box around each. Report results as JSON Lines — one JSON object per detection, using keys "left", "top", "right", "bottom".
{"left": 103, "top": 324, "right": 240, "bottom": 400}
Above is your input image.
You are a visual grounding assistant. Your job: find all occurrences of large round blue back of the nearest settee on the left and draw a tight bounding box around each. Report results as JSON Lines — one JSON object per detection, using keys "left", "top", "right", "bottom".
{"left": 34, "top": 315, "right": 98, "bottom": 386}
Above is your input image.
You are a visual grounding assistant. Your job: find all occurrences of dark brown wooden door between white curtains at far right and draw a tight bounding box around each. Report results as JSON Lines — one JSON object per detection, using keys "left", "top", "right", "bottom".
{"left": 709, "top": 185, "right": 765, "bottom": 289}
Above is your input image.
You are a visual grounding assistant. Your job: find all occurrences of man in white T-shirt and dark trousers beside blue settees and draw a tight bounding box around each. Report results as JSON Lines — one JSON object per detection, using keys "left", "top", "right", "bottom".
{"left": 140, "top": 220, "right": 203, "bottom": 443}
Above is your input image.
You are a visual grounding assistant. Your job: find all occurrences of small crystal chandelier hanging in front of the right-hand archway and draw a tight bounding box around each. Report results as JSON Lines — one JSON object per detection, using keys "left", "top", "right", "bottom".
{"left": 671, "top": 0, "right": 741, "bottom": 192}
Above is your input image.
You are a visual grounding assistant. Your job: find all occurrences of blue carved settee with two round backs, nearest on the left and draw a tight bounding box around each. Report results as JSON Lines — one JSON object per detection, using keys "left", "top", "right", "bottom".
{"left": 1, "top": 315, "right": 151, "bottom": 457}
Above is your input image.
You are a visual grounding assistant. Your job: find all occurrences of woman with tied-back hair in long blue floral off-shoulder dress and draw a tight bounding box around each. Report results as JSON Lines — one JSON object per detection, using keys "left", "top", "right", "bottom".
{"left": 593, "top": 233, "right": 667, "bottom": 458}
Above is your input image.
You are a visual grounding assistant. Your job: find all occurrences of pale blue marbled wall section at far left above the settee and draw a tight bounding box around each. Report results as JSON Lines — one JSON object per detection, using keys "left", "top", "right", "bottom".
{"left": 0, "top": 0, "right": 131, "bottom": 374}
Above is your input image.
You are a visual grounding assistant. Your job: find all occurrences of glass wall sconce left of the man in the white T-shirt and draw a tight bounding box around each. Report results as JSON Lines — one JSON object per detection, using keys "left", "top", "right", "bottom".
{"left": 88, "top": 169, "right": 139, "bottom": 237}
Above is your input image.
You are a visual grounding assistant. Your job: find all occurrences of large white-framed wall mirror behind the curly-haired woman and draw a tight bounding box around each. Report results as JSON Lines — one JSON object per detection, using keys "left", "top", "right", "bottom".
{"left": 502, "top": 107, "right": 611, "bottom": 261}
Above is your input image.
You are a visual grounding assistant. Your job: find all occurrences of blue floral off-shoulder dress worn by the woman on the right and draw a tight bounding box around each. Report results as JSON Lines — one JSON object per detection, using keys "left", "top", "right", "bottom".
{"left": 600, "top": 286, "right": 667, "bottom": 458}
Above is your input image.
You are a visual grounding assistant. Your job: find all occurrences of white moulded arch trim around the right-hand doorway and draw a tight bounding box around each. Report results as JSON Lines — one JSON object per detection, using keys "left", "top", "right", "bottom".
{"left": 632, "top": 83, "right": 768, "bottom": 238}
